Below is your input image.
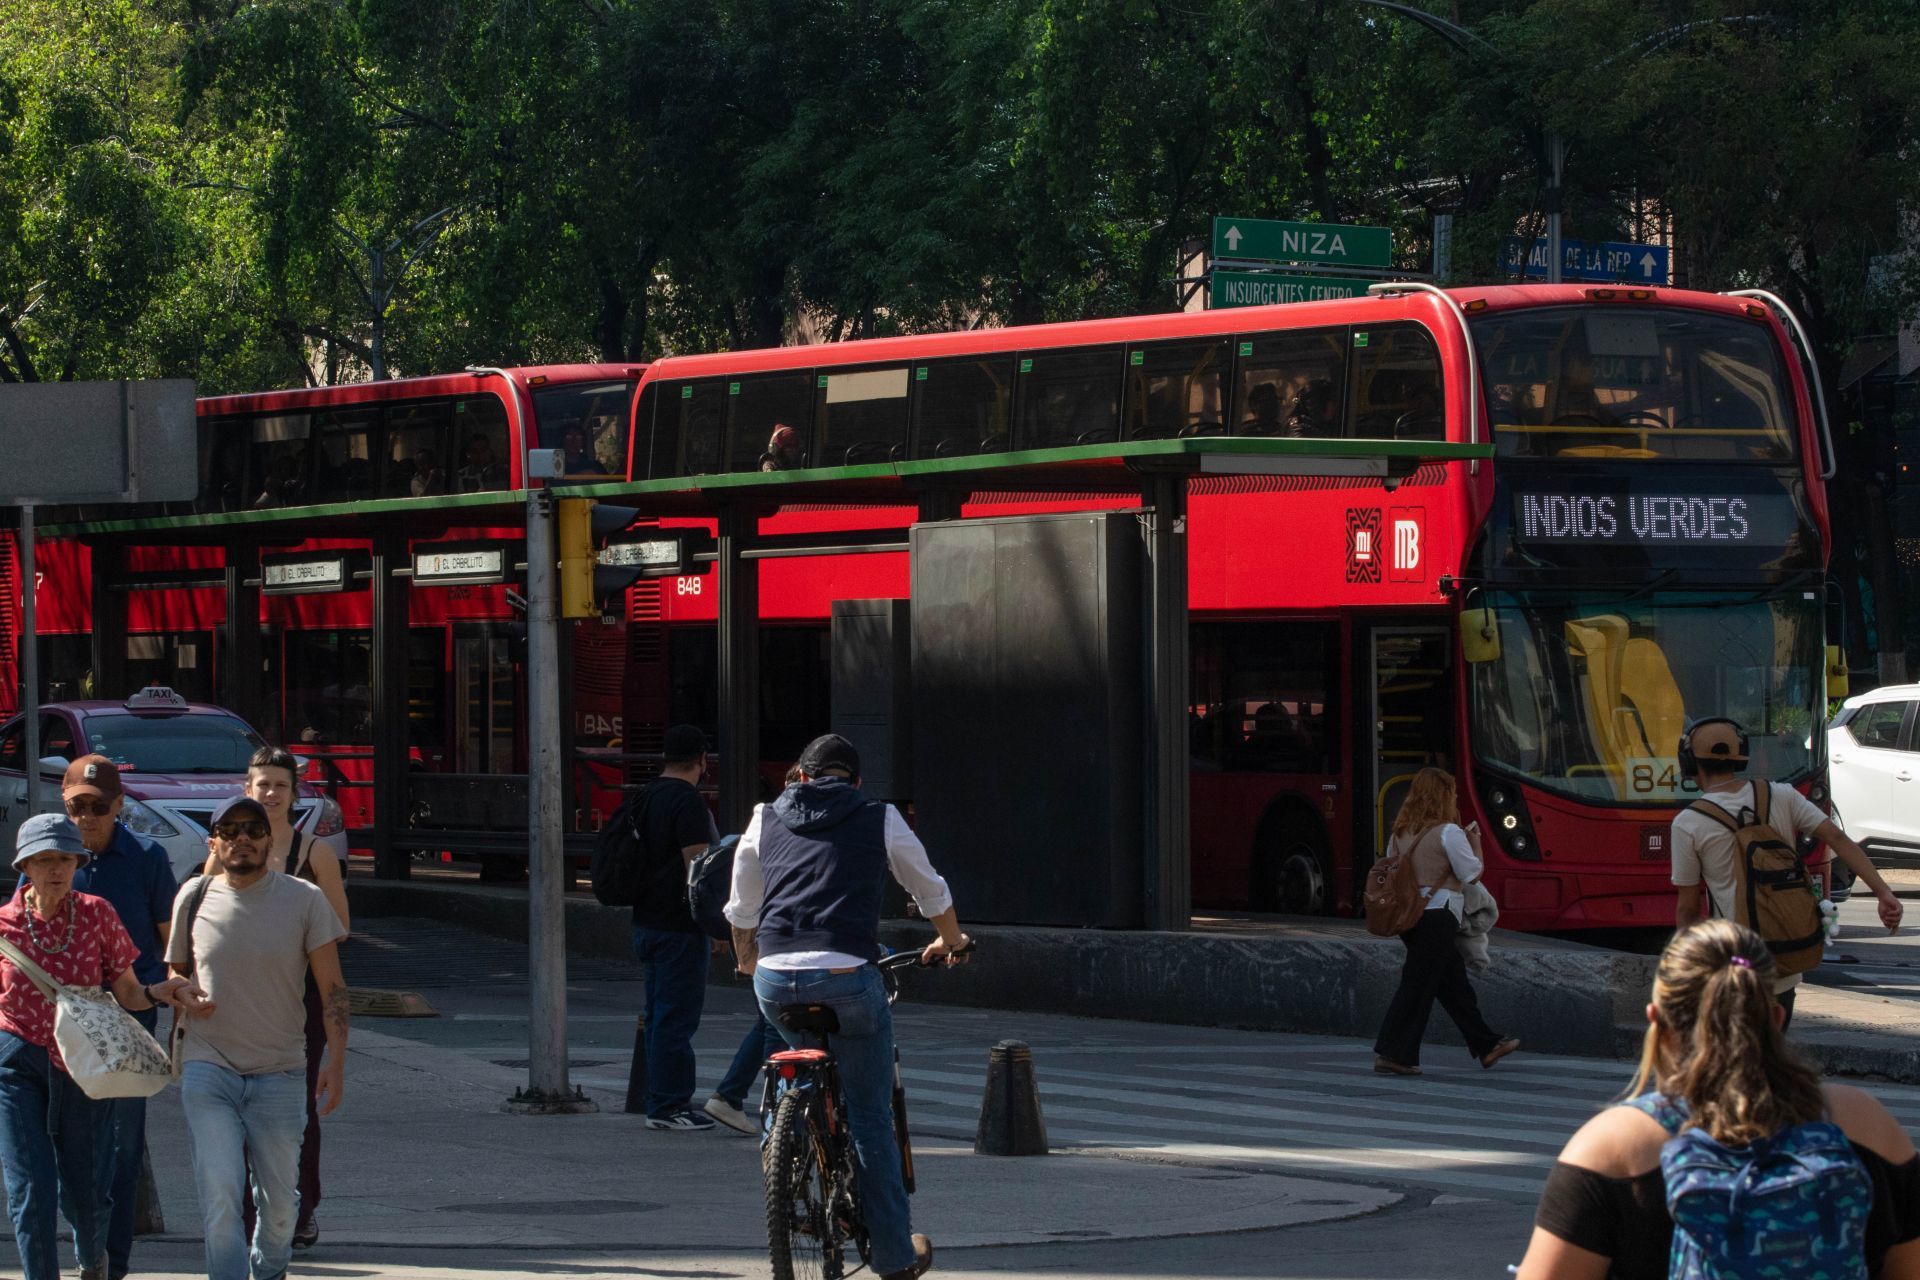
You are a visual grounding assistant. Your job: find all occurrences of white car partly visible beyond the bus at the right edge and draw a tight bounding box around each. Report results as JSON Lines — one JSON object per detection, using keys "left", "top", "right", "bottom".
{"left": 1826, "top": 685, "right": 1920, "bottom": 865}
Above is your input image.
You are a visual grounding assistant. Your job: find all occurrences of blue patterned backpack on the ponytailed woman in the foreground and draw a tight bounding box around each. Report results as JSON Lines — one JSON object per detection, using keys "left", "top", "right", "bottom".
{"left": 1626, "top": 1094, "right": 1874, "bottom": 1280}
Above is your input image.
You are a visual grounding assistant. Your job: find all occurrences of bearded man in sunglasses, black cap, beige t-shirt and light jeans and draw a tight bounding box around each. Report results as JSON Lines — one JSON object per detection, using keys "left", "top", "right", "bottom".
{"left": 167, "top": 796, "right": 348, "bottom": 1280}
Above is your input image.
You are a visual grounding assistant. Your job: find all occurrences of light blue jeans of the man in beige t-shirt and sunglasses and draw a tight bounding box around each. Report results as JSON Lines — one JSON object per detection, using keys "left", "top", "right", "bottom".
{"left": 180, "top": 1061, "right": 307, "bottom": 1280}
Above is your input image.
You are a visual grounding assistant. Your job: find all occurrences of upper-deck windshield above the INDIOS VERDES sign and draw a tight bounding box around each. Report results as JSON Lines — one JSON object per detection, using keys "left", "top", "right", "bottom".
{"left": 1473, "top": 303, "right": 1795, "bottom": 462}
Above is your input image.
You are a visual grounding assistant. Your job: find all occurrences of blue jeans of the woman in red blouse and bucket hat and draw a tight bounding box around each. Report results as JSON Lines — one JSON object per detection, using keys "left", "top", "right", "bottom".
{"left": 0, "top": 1031, "right": 108, "bottom": 1280}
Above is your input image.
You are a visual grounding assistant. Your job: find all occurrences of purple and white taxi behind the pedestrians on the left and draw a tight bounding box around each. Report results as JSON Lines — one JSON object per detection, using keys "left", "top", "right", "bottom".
{"left": 0, "top": 687, "right": 348, "bottom": 879}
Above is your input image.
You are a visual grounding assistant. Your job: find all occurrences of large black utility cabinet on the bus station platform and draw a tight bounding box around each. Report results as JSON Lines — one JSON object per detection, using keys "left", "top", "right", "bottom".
{"left": 912, "top": 510, "right": 1146, "bottom": 929}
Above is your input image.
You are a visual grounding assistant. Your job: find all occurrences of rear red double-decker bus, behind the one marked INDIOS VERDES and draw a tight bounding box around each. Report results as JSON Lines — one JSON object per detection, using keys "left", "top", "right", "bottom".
{"left": 0, "top": 365, "right": 641, "bottom": 839}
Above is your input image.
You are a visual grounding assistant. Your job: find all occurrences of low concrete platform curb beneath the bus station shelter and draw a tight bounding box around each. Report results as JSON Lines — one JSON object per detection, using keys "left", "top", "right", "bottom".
{"left": 353, "top": 879, "right": 1653, "bottom": 1057}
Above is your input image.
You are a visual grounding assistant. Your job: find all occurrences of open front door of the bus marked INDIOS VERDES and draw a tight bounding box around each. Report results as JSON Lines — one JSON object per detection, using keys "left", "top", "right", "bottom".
{"left": 1356, "top": 624, "right": 1453, "bottom": 858}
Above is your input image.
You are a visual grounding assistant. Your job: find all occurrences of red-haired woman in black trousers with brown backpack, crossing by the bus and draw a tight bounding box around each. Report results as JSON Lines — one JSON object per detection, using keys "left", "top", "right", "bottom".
{"left": 1373, "top": 766, "right": 1521, "bottom": 1075}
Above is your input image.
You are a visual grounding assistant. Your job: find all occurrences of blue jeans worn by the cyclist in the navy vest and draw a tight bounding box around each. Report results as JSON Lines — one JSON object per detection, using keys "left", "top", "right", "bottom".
{"left": 753, "top": 965, "right": 914, "bottom": 1276}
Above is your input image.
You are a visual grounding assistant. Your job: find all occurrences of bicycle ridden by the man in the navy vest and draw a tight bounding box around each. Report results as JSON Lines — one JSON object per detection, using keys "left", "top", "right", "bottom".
{"left": 760, "top": 938, "right": 973, "bottom": 1280}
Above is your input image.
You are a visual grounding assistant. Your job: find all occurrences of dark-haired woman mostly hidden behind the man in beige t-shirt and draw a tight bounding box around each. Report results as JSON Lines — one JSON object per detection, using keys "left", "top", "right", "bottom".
{"left": 205, "top": 747, "right": 351, "bottom": 1249}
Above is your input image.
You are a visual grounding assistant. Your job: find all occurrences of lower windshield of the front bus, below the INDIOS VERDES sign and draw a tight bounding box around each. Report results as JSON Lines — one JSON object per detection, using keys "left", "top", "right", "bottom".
{"left": 1467, "top": 591, "right": 1824, "bottom": 804}
